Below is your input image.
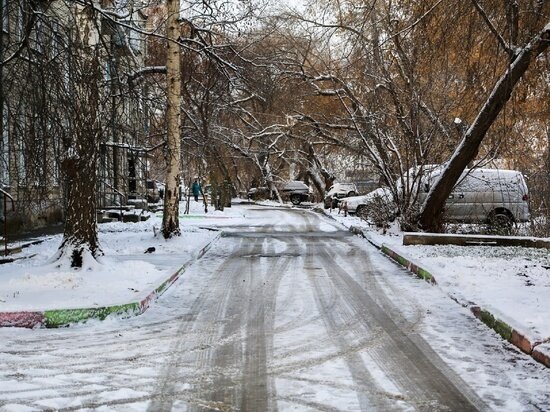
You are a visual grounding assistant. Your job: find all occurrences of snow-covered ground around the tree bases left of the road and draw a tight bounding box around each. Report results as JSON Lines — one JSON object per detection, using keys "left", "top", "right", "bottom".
{"left": 0, "top": 202, "right": 244, "bottom": 312}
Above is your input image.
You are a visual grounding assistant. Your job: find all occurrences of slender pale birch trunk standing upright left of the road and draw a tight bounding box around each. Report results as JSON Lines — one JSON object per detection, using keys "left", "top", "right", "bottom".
{"left": 162, "top": 0, "right": 181, "bottom": 239}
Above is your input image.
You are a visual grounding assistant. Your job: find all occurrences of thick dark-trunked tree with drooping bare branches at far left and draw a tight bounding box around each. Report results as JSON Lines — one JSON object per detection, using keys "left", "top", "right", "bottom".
{"left": 2, "top": 2, "right": 114, "bottom": 267}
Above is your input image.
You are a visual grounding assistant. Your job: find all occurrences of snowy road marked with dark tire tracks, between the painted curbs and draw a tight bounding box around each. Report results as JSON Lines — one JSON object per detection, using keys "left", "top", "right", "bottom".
{"left": 0, "top": 209, "right": 550, "bottom": 411}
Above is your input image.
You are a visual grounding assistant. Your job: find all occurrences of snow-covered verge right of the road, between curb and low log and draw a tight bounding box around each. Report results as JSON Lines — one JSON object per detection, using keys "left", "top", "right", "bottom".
{"left": 329, "top": 210, "right": 550, "bottom": 342}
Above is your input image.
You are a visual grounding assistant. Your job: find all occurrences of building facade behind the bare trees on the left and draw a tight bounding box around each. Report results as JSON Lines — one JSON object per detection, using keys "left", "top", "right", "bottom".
{"left": 0, "top": 0, "right": 155, "bottom": 232}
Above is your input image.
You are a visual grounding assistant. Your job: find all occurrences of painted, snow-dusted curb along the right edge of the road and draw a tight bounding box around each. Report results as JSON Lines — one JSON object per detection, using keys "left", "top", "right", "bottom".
{"left": 349, "top": 226, "right": 550, "bottom": 368}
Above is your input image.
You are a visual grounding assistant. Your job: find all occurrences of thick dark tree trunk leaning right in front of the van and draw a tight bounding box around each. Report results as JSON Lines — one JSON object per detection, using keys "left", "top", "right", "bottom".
{"left": 418, "top": 23, "right": 550, "bottom": 232}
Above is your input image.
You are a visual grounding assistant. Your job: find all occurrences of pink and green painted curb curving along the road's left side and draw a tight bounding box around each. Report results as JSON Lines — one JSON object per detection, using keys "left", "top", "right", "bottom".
{"left": 0, "top": 232, "right": 221, "bottom": 329}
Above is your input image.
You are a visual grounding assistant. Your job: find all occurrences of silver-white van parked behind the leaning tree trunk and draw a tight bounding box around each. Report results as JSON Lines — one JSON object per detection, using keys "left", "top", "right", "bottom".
{"left": 418, "top": 168, "right": 529, "bottom": 225}
